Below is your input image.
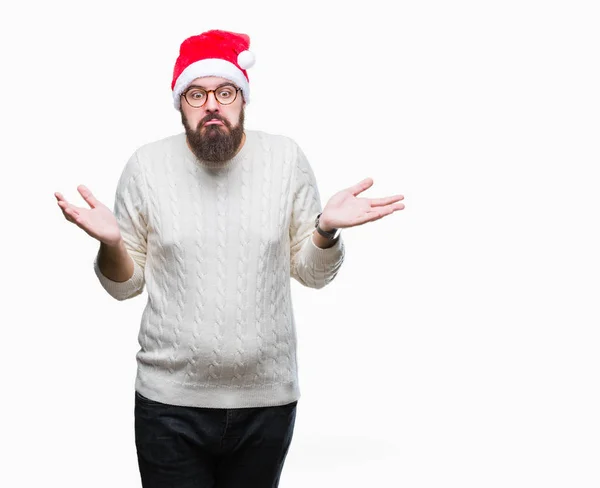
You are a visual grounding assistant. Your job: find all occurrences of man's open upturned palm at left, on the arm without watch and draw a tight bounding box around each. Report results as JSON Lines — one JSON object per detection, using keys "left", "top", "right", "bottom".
{"left": 54, "top": 185, "right": 121, "bottom": 247}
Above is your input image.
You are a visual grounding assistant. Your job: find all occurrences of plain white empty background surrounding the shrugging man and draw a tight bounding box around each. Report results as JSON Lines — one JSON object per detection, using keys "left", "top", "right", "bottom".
{"left": 0, "top": 0, "right": 600, "bottom": 488}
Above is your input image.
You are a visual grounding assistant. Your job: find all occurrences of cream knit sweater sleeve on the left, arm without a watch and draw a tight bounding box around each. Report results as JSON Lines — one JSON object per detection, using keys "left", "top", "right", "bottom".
{"left": 94, "top": 153, "right": 148, "bottom": 300}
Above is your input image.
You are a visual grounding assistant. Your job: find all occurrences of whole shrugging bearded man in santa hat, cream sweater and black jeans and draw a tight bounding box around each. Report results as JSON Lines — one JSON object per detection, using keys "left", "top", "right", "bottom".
{"left": 55, "top": 30, "right": 404, "bottom": 488}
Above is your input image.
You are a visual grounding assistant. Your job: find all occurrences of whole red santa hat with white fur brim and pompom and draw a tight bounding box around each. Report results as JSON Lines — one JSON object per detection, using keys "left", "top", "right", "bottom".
{"left": 171, "top": 30, "right": 254, "bottom": 110}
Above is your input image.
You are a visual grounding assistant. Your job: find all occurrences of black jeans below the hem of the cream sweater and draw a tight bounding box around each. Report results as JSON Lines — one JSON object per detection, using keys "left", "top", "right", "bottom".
{"left": 135, "top": 392, "right": 298, "bottom": 488}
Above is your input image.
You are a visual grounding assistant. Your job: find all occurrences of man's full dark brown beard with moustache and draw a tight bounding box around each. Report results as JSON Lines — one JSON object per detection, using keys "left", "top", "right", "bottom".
{"left": 181, "top": 108, "right": 244, "bottom": 163}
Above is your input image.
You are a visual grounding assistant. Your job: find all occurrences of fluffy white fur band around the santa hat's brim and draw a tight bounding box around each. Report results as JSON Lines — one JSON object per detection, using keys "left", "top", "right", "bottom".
{"left": 173, "top": 58, "right": 250, "bottom": 110}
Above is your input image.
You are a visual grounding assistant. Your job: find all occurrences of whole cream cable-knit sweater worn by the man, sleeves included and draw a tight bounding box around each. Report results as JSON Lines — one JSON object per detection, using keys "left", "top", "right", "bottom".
{"left": 94, "top": 130, "right": 344, "bottom": 408}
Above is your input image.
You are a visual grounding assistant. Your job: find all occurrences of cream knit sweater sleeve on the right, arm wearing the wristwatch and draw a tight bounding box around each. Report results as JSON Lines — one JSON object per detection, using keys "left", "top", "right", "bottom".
{"left": 290, "top": 145, "right": 345, "bottom": 289}
